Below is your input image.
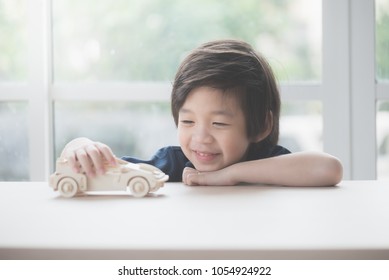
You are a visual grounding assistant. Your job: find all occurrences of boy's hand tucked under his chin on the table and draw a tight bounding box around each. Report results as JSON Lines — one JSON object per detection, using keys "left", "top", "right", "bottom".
{"left": 182, "top": 167, "right": 235, "bottom": 186}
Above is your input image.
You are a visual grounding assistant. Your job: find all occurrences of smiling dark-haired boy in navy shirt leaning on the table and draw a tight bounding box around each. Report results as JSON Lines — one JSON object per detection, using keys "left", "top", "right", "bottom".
{"left": 61, "top": 40, "right": 342, "bottom": 186}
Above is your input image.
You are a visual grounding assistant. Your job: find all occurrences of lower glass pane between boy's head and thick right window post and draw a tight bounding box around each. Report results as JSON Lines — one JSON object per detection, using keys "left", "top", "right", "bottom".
{"left": 279, "top": 101, "right": 323, "bottom": 152}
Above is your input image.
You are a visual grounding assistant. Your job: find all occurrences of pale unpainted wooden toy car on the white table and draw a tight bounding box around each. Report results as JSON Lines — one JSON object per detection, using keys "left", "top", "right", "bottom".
{"left": 49, "top": 158, "right": 169, "bottom": 197}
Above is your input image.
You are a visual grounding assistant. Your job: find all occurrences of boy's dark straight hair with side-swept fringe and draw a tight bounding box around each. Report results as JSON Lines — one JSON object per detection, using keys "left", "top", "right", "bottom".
{"left": 171, "top": 40, "right": 280, "bottom": 148}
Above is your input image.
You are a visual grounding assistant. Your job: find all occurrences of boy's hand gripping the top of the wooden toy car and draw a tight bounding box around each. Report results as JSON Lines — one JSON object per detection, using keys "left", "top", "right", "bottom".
{"left": 61, "top": 138, "right": 117, "bottom": 176}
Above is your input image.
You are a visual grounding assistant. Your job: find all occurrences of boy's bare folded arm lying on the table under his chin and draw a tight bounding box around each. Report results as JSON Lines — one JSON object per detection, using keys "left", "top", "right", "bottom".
{"left": 182, "top": 152, "right": 343, "bottom": 186}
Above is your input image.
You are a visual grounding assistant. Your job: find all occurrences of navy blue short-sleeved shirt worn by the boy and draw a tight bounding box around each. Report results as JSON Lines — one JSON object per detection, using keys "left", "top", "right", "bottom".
{"left": 122, "top": 146, "right": 290, "bottom": 182}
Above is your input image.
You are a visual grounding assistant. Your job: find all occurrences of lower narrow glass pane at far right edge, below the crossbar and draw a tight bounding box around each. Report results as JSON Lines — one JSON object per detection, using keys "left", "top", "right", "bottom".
{"left": 377, "top": 101, "right": 389, "bottom": 179}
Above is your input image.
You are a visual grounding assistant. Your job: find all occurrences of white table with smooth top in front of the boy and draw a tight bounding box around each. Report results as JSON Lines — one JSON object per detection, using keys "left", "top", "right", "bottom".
{"left": 0, "top": 181, "right": 389, "bottom": 259}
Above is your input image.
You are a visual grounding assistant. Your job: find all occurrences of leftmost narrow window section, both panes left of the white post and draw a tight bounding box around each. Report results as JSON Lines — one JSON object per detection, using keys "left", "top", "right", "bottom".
{"left": 0, "top": 0, "right": 29, "bottom": 180}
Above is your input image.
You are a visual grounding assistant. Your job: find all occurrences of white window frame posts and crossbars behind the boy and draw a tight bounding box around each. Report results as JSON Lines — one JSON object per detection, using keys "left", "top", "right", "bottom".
{"left": 0, "top": 0, "right": 389, "bottom": 181}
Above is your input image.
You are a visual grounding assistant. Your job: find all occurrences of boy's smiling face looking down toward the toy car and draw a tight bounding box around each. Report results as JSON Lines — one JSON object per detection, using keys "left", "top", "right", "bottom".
{"left": 178, "top": 87, "right": 250, "bottom": 171}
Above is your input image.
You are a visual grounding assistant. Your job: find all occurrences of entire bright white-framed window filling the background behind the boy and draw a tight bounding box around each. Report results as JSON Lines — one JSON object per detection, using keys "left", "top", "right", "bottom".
{"left": 0, "top": 0, "right": 389, "bottom": 180}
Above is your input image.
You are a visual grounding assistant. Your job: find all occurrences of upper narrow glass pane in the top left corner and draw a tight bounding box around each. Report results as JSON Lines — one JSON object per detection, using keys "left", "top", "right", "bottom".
{"left": 0, "top": 0, "right": 27, "bottom": 82}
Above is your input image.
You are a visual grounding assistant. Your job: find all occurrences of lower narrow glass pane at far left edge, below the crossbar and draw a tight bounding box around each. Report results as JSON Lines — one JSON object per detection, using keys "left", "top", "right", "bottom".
{"left": 0, "top": 102, "right": 29, "bottom": 181}
